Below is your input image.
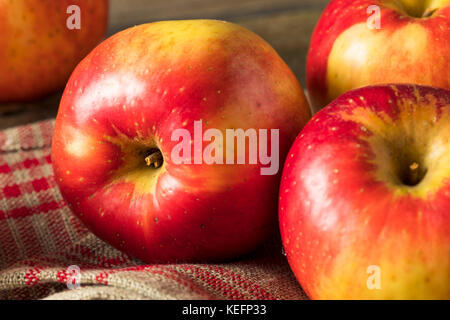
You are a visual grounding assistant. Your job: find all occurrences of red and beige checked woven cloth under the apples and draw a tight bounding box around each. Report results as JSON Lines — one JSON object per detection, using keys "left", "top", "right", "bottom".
{"left": 0, "top": 120, "right": 306, "bottom": 299}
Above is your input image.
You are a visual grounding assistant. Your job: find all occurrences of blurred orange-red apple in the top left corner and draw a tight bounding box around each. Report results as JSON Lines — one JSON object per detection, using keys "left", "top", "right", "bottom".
{"left": 0, "top": 0, "right": 108, "bottom": 102}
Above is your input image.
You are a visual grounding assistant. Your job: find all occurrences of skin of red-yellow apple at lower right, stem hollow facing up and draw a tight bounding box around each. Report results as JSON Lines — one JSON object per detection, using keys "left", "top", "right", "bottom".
{"left": 279, "top": 85, "right": 450, "bottom": 299}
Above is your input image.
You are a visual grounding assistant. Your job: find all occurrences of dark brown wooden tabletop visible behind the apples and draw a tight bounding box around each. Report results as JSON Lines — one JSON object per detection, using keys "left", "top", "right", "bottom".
{"left": 0, "top": 0, "right": 328, "bottom": 129}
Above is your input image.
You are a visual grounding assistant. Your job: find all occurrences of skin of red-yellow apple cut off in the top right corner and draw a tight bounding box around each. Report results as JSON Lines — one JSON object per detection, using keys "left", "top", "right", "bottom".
{"left": 306, "top": 0, "right": 450, "bottom": 111}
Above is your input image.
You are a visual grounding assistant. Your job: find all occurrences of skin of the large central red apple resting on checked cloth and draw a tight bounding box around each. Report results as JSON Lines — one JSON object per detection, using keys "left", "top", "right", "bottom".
{"left": 52, "top": 20, "right": 310, "bottom": 263}
